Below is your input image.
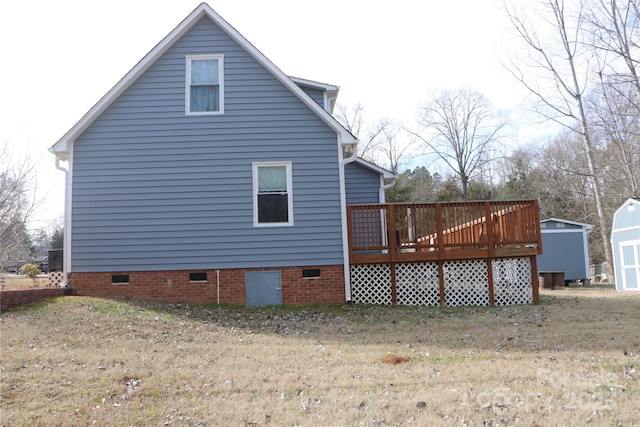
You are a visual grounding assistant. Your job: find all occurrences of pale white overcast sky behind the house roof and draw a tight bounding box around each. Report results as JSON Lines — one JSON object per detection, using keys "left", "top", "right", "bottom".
{"left": 0, "top": 0, "right": 526, "bottom": 228}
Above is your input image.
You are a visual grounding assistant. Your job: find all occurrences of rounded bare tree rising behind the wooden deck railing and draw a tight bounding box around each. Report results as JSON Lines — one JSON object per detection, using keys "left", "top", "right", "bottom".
{"left": 410, "top": 88, "right": 507, "bottom": 200}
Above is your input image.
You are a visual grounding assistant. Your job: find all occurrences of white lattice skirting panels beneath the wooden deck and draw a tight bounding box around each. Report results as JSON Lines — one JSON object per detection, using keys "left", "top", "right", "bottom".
{"left": 351, "top": 258, "right": 533, "bottom": 307}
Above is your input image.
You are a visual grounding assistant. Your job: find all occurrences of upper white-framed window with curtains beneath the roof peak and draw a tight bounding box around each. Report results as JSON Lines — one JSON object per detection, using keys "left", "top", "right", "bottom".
{"left": 186, "top": 55, "right": 224, "bottom": 114}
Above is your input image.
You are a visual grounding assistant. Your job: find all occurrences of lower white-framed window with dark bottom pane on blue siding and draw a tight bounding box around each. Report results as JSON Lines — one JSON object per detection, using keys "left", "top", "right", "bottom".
{"left": 253, "top": 162, "right": 293, "bottom": 226}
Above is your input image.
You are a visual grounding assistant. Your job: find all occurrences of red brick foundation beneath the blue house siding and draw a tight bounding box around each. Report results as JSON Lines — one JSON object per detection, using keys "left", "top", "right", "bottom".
{"left": 69, "top": 265, "right": 345, "bottom": 305}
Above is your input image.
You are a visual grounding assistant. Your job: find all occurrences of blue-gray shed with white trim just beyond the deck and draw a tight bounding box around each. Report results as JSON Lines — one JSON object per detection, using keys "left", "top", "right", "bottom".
{"left": 537, "top": 218, "right": 593, "bottom": 282}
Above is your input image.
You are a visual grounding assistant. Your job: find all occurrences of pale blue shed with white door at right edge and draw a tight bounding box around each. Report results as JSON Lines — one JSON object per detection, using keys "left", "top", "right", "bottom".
{"left": 611, "top": 198, "right": 640, "bottom": 291}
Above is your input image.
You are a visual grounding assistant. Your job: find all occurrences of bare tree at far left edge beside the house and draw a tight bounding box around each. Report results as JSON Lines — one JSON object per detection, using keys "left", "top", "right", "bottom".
{"left": 0, "top": 143, "right": 36, "bottom": 273}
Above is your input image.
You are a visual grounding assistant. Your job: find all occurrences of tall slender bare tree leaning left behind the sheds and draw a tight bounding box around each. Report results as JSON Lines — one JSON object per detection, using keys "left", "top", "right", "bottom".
{"left": 507, "top": 0, "right": 613, "bottom": 278}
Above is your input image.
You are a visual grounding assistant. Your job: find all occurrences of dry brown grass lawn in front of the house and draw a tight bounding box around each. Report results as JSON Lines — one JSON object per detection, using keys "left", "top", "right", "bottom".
{"left": 0, "top": 290, "right": 640, "bottom": 426}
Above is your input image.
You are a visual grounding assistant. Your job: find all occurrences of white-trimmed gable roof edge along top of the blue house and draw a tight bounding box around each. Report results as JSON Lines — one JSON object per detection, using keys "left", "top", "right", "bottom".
{"left": 49, "top": 3, "right": 357, "bottom": 159}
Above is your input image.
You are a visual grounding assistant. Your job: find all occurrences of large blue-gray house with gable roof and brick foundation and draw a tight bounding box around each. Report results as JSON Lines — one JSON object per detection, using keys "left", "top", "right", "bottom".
{"left": 50, "top": 3, "right": 393, "bottom": 305}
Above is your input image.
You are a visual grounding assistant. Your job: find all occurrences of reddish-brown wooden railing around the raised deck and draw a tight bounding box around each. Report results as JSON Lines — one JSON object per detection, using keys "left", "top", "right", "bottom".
{"left": 347, "top": 200, "right": 542, "bottom": 264}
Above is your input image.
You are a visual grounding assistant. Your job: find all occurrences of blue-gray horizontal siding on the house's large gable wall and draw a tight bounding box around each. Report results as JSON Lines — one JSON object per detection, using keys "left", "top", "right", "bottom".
{"left": 72, "top": 18, "right": 343, "bottom": 272}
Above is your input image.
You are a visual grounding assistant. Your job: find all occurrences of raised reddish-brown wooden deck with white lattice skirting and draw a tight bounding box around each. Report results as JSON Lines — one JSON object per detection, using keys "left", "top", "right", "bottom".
{"left": 347, "top": 200, "right": 542, "bottom": 306}
